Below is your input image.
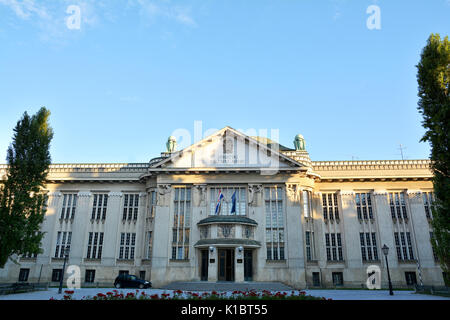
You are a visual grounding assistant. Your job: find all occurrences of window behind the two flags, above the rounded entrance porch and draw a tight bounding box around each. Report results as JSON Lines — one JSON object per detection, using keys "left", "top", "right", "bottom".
{"left": 209, "top": 187, "right": 247, "bottom": 216}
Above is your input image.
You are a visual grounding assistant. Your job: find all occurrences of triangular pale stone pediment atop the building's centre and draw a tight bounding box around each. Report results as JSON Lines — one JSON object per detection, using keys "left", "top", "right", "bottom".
{"left": 152, "top": 127, "right": 304, "bottom": 169}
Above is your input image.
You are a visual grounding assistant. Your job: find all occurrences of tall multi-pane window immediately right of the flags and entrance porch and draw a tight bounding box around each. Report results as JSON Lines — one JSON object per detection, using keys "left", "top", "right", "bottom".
{"left": 264, "top": 186, "right": 285, "bottom": 260}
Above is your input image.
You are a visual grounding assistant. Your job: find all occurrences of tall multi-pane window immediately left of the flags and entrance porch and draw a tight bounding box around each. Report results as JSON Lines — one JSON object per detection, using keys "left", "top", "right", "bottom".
{"left": 172, "top": 187, "right": 191, "bottom": 260}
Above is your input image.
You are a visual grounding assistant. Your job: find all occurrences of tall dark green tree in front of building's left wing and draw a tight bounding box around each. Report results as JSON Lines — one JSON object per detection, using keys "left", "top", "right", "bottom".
{"left": 0, "top": 107, "right": 53, "bottom": 268}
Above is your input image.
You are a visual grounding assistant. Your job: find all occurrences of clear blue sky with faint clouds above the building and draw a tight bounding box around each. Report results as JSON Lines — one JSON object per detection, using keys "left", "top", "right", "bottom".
{"left": 0, "top": 0, "right": 450, "bottom": 163}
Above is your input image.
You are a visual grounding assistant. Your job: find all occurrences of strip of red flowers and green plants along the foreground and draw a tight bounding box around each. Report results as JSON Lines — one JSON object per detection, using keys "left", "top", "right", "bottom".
{"left": 55, "top": 290, "right": 331, "bottom": 300}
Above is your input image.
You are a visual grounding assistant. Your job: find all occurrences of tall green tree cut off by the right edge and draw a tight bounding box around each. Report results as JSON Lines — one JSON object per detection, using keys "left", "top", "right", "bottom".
{"left": 417, "top": 34, "right": 450, "bottom": 284}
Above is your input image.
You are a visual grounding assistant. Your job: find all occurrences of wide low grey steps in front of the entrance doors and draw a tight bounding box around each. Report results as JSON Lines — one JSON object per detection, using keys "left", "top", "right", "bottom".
{"left": 161, "top": 281, "right": 294, "bottom": 292}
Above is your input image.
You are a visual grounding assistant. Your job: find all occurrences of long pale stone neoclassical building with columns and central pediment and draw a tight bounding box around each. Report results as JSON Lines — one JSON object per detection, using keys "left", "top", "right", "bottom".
{"left": 0, "top": 127, "right": 444, "bottom": 288}
